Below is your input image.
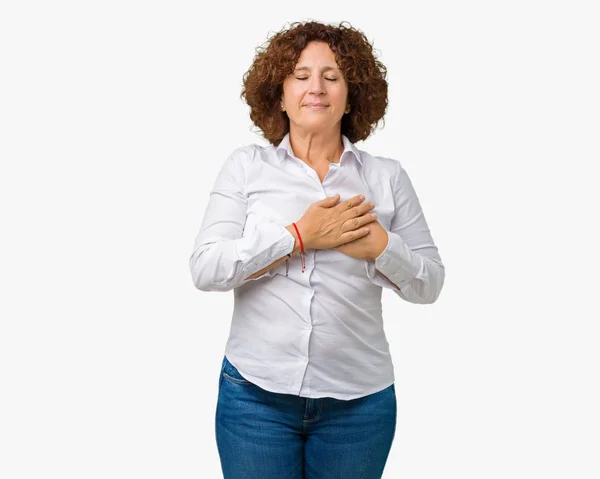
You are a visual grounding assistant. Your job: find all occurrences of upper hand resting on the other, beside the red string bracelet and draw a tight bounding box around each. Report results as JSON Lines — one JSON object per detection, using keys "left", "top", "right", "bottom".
{"left": 287, "top": 194, "right": 376, "bottom": 249}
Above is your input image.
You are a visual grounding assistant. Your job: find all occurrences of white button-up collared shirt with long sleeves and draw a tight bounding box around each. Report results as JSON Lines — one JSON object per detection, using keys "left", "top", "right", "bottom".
{"left": 189, "top": 133, "right": 445, "bottom": 400}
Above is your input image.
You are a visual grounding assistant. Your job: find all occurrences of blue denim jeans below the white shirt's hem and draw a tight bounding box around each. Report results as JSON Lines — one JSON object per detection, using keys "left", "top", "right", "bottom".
{"left": 215, "top": 357, "right": 396, "bottom": 479}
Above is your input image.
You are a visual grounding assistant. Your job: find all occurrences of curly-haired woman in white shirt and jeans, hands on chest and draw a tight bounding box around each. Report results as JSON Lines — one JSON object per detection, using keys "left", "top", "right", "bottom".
{"left": 190, "top": 22, "right": 445, "bottom": 479}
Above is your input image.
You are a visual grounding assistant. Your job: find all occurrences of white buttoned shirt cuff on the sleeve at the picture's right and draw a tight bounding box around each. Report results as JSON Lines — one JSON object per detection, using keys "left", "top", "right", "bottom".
{"left": 366, "top": 231, "right": 423, "bottom": 289}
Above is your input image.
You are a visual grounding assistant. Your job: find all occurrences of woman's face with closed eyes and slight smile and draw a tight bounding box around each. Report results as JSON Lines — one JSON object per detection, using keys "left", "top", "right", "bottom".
{"left": 281, "top": 41, "right": 348, "bottom": 133}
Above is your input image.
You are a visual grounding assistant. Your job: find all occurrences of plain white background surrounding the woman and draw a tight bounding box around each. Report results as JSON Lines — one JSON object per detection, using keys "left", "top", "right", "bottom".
{"left": 0, "top": 0, "right": 600, "bottom": 479}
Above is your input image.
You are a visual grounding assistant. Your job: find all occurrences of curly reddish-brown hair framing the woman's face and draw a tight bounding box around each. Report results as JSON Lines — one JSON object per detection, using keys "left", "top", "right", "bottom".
{"left": 240, "top": 21, "right": 388, "bottom": 146}
